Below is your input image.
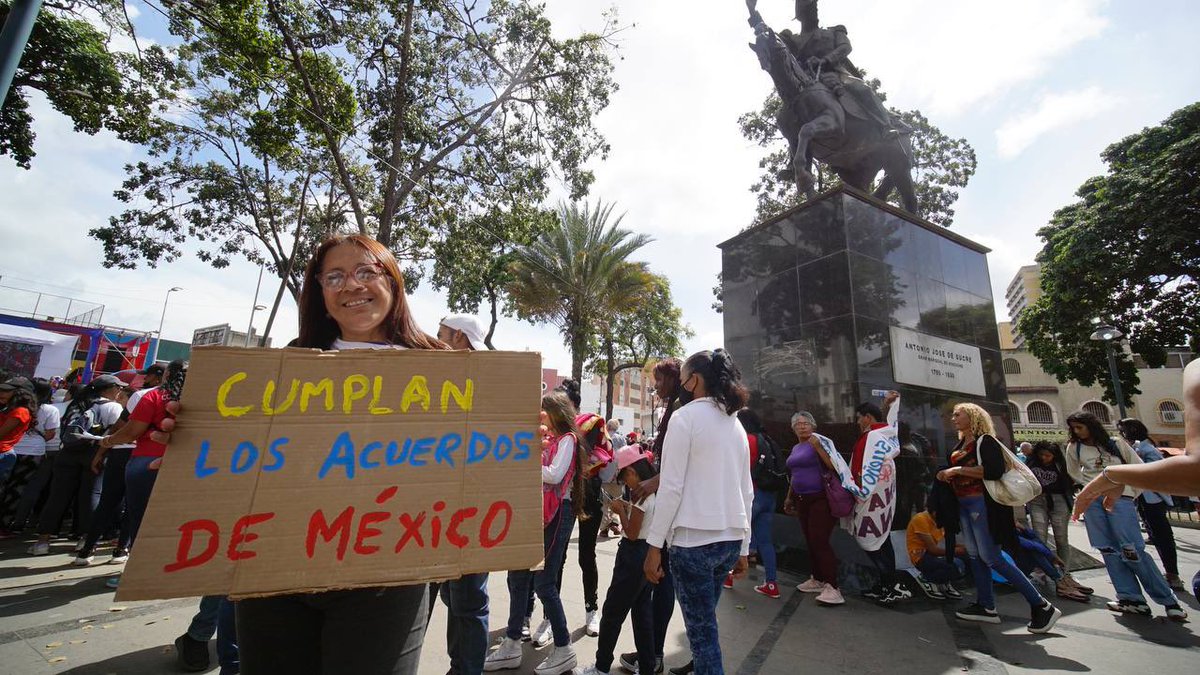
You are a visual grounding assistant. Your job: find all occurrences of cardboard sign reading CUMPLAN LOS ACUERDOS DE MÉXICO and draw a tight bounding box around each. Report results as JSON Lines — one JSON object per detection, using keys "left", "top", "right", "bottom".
{"left": 116, "top": 347, "right": 542, "bottom": 601}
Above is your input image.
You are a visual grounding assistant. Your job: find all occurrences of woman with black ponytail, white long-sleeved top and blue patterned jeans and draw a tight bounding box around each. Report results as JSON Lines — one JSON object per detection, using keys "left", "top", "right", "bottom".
{"left": 644, "top": 350, "right": 754, "bottom": 675}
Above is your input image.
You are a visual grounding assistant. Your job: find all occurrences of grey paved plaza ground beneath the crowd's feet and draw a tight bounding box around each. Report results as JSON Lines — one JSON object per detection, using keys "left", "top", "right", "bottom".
{"left": 0, "top": 516, "right": 1200, "bottom": 675}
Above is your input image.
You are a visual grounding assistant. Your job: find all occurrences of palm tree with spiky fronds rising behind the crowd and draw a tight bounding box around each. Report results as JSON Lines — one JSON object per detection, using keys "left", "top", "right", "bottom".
{"left": 508, "top": 202, "right": 653, "bottom": 381}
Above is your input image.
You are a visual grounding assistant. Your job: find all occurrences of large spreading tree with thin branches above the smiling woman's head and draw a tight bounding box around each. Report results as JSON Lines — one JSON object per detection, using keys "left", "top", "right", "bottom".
{"left": 92, "top": 0, "right": 618, "bottom": 305}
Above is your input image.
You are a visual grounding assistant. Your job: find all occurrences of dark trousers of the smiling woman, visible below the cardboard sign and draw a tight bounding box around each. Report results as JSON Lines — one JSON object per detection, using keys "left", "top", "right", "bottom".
{"left": 235, "top": 584, "right": 430, "bottom": 675}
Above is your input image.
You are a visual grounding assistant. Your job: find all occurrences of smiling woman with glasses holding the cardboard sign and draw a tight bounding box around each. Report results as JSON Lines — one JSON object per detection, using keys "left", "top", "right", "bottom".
{"left": 152, "top": 234, "right": 449, "bottom": 675}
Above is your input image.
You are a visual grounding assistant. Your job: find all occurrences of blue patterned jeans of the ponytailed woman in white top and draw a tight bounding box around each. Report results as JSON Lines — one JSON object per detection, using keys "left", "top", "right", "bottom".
{"left": 671, "top": 542, "right": 742, "bottom": 675}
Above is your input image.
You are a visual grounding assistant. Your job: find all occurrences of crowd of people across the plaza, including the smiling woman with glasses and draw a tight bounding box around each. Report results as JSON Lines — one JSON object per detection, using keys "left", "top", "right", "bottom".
{"left": 0, "top": 230, "right": 1200, "bottom": 675}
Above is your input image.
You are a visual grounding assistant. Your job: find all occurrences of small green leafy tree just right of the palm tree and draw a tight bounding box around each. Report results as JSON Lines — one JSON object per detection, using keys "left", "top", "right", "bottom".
{"left": 592, "top": 274, "right": 694, "bottom": 418}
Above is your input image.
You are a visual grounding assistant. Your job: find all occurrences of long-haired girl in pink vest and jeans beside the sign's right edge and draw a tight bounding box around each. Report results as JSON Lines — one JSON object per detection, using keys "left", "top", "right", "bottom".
{"left": 484, "top": 392, "right": 590, "bottom": 675}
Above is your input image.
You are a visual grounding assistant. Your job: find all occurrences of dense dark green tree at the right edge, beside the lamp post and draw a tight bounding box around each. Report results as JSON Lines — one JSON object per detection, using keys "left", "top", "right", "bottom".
{"left": 1018, "top": 103, "right": 1200, "bottom": 404}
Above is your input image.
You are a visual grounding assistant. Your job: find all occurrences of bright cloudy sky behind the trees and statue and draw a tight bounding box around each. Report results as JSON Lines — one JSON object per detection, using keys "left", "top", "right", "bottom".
{"left": 0, "top": 0, "right": 1200, "bottom": 370}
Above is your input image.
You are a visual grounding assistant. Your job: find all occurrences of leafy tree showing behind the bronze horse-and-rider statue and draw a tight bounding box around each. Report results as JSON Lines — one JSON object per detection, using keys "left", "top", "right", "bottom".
{"left": 738, "top": 79, "right": 976, "bottom": 227}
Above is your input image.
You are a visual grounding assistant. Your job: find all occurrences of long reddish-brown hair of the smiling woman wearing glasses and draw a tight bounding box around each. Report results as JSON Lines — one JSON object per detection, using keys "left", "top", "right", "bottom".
{"left": 295, "top": 234, "right": 450, "bottom": 350}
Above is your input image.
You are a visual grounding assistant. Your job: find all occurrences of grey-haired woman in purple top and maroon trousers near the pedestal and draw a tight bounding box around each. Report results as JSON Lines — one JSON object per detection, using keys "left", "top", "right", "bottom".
{"left": 784, "top": 412, "right": 846, "bottom": 605}
